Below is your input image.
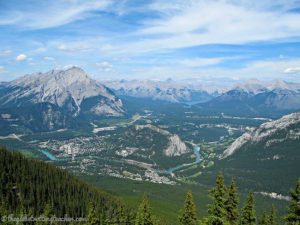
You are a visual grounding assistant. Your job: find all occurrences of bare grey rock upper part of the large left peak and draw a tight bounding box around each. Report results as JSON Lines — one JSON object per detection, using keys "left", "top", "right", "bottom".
{"left": 0, "top": 67, "right": 123, "bottom": 117}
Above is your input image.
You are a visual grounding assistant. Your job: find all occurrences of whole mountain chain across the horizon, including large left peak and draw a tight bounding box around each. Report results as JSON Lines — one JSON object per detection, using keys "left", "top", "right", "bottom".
{"left": 0, "top": 67, "right": 300, "bottom": 134}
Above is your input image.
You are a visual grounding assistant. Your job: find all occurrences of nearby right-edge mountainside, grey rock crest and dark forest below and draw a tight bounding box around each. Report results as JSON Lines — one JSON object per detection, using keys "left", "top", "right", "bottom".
{"left": 202, "top": 112, "right": 300, "bottom": 195}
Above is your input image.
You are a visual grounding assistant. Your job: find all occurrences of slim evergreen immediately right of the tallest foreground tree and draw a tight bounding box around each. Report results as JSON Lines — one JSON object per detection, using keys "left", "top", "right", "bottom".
{"left": 225, "top": 179, "right": 239, "bottom": 225}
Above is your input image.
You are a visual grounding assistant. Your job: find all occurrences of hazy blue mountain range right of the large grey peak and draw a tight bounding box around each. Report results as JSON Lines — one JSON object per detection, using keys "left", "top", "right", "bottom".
{"left": 105, "top": 79, "right": 300, "bottom": 118}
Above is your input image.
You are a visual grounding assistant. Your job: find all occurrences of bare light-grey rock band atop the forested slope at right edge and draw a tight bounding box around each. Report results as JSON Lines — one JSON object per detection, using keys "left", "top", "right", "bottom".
{"left": 222, "top": 112, "right": 300, "bottom": 158}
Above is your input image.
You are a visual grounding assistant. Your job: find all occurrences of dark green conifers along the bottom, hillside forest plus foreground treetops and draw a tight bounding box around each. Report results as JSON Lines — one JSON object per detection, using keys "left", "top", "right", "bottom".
{"left": 0, "top": 148, "right": 300, "bottom": 225}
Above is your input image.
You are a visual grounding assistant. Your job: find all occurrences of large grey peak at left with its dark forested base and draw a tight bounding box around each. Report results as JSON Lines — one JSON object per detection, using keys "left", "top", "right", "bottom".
{"left": 0, "top": 67, "right": 124, "bottom": 131}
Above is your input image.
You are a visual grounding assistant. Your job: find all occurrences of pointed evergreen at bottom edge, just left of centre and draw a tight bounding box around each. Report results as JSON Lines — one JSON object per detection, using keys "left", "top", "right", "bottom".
{"left": 135, "top": 196, "right": 158, "bottom": 225}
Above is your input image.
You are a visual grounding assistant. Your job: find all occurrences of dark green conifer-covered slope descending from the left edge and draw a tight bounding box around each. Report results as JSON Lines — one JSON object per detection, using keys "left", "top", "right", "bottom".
{"left": 0, "top": 148, "right": 130, "bottom": 221}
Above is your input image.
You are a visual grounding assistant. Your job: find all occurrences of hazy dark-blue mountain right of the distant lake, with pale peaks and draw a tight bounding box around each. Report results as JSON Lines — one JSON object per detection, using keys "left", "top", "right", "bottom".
{"left": 198, "top": 80, "right": 300, "bottom": 118}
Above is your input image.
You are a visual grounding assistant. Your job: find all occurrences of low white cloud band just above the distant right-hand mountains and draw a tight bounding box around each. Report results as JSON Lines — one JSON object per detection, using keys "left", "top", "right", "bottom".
{"left": 126, "top": 58, "right": 300, "bottom": 83}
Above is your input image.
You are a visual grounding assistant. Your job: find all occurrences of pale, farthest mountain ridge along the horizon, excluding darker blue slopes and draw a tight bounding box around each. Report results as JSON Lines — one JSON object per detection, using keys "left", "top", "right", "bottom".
{"left": 105, "top": 79, "right": 300, "bottom": 107}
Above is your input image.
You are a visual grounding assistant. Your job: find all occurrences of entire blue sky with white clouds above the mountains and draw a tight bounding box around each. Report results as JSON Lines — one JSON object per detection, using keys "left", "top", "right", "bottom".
{"left": 0, "top": 0, "right": 300, "bottom": 81}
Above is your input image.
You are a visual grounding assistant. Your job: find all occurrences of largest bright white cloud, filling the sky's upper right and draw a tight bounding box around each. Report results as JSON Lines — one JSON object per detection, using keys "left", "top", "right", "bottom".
{"left": 110, "top": 0, "right": 300, "bottom": 53}
